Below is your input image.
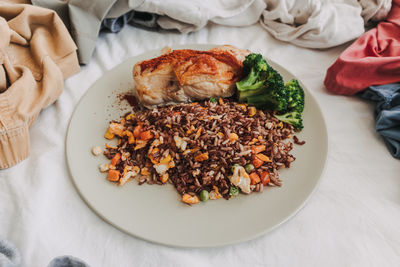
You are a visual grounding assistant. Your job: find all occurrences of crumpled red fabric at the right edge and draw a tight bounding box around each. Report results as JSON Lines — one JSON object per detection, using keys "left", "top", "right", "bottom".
{"left": 324, "top": 0, "right": 400, "bottom": 95}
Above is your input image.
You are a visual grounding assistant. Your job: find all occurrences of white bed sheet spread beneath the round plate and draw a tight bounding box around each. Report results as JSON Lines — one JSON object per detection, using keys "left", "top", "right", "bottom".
{"left": 0, "top": 24, "right": 400, "bottom": 267}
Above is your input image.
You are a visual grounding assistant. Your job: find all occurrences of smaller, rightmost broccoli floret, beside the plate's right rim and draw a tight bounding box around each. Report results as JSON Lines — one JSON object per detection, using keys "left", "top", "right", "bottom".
{"left": 275, "top": 79, "right": 304, "bottom": 130}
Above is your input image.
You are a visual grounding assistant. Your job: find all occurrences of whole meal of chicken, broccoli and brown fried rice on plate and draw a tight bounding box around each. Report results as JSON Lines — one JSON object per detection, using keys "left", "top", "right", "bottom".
{"left": 97, "top": 46, "right": 305, "bottom": 205}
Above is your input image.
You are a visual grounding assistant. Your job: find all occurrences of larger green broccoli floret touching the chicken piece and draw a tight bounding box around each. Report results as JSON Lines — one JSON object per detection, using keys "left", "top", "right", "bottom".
{"left": 236, "top": 54, "right": 288, "bottom": 111}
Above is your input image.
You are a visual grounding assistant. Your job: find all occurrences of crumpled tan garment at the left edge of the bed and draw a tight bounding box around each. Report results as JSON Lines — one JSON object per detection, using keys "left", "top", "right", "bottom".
{"left": 0, "top": 2, "right": 79, "bottom": 169}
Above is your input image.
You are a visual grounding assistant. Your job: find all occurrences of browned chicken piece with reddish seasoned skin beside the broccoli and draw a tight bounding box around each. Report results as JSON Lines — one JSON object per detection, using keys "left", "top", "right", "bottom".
{"left": 133, "top": 45, "right": 250, "bottom": 108}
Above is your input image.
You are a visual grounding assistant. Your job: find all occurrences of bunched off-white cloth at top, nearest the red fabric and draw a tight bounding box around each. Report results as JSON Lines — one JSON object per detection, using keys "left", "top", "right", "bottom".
{"left": 261, "top": 0, "right": 364, "bottom": 48}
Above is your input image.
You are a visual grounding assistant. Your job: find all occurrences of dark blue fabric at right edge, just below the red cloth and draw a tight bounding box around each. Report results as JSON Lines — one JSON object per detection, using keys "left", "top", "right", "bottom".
{"left": 361, "top": 83, "right": 400, "bottom": 158}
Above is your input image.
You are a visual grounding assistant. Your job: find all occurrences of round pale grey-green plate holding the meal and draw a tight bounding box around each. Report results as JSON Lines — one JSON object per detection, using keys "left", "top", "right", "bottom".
{"left": 66, "top": 45, "right": 328, "bottom": 247}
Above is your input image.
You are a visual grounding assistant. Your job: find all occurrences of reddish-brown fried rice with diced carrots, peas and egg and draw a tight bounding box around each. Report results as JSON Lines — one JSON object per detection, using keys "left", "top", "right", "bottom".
{"left": 101, "top": 98, "right": 304, "bottom": 204}
